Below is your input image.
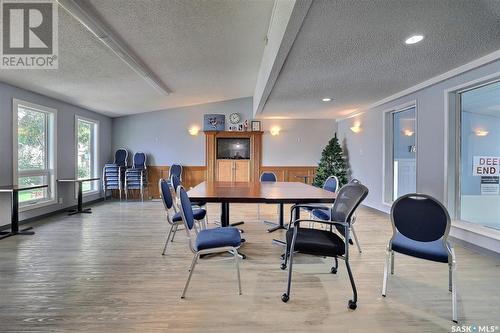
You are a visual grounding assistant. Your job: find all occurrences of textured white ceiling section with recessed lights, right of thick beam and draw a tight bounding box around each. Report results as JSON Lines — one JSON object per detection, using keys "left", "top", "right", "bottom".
{"left": 261, "top": 0, "right": 500, "bottom": 118}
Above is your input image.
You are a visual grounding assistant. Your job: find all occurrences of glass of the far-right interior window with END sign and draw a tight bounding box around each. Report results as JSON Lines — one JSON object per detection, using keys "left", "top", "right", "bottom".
{"left": 457, "top": 82, "right": 500, "bottom": 229}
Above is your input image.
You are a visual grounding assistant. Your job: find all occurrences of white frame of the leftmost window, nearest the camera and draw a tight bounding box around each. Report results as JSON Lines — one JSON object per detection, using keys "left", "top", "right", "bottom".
{"left": 12, "top": 98, "right": 57, "bottom": 212}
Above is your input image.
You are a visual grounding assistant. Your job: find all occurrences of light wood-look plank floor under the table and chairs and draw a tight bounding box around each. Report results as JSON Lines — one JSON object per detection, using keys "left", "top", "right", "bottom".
{"left": 0, "top": 201, "right": 500, "bottom": 332}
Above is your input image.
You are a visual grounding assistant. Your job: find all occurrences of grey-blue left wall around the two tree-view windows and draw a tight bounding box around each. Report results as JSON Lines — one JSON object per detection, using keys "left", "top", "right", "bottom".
{"left": 0, "top": 82, "right": 111, "bottom": 226}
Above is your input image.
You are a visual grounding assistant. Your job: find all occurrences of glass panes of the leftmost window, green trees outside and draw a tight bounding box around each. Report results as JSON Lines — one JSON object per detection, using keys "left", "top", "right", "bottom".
{"left": 12, "top": 99, "right": 57, "bottom": 208}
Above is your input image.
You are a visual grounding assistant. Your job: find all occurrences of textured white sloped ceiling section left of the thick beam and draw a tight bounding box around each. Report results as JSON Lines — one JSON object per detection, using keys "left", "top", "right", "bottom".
{"left": 0, "top": 0, "right": 273, "bottom": 116}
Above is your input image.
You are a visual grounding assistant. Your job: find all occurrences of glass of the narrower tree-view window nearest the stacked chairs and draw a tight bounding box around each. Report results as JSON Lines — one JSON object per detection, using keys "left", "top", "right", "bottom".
{"left": 75, "top": 116, "right": 99, "bottom": 193}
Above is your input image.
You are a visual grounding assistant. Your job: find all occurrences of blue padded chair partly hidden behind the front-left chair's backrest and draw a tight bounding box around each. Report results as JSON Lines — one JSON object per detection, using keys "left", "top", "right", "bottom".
{"left": 158, "top": 179, "right": 207, "bottom": 255}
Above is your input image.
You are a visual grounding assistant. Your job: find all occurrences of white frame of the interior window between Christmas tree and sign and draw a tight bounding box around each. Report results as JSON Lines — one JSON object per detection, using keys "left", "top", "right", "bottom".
{"left": 382, "top": 100, "right": 419, "bottom": 207}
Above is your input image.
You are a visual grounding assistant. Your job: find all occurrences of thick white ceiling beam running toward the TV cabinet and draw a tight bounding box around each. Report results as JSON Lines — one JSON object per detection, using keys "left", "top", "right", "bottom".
{"left": 253, "top": 0, "right": 312, "bottom": 117}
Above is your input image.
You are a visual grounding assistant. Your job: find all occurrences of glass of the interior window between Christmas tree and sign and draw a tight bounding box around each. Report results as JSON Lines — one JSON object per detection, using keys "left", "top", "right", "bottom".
{"left": 384, "top": 105, "right": 417, "bottom": 204}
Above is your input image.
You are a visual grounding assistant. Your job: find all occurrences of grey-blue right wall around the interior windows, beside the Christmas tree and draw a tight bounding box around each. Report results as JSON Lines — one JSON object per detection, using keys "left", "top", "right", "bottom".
{"left": 338, "top": 60, "right": 500, "bottom": 212}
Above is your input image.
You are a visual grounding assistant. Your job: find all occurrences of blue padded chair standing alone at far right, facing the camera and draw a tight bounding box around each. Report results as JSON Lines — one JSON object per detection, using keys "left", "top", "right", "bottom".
{"left": 382, "top": 193, "right": 457, "bottom": 322}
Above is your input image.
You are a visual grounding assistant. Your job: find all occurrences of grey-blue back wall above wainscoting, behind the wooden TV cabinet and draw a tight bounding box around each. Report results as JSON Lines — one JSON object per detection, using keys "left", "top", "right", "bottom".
{"left": 113, "top": 97, "right": 336, "bottom": 166}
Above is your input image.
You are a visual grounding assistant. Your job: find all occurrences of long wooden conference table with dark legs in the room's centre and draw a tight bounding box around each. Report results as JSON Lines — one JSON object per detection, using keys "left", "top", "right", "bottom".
{"left": 188, "top": 181, "right": 336, "bottom": 232}
